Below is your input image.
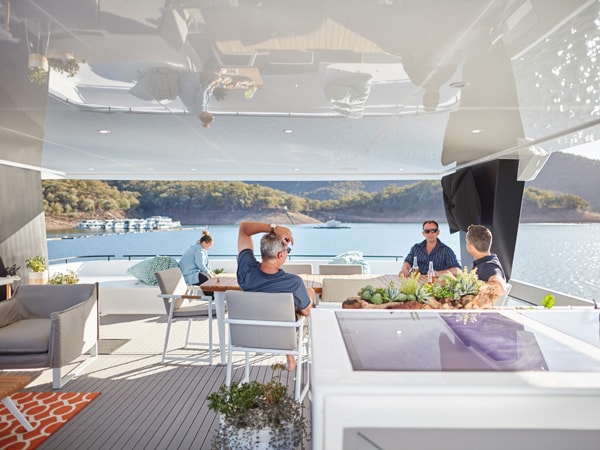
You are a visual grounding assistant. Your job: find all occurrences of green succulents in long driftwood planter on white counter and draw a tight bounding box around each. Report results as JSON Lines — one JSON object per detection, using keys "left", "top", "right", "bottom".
{"left": 342, "top": 268, "right": 499, "bottom": 309}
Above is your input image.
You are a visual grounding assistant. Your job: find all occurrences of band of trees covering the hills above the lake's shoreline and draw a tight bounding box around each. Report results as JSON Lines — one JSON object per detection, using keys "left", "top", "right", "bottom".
{"left": 42, "top": 180, "right": 590, "bottom": 219}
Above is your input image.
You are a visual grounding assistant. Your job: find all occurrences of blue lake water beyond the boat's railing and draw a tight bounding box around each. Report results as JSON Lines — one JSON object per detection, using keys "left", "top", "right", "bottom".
{"left": 48, "top": 223, "right": 600, "bottom": 300}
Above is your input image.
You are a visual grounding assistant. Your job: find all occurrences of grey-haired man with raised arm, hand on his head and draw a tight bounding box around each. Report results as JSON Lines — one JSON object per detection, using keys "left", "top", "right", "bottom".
{"left": 237, "top": 222, "right": 315, "bottom": 370}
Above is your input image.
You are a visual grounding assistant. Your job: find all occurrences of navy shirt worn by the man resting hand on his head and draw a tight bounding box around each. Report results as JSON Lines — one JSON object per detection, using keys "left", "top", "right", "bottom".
{"left": 237, "top": 248, "right": 310, "bottom": 309}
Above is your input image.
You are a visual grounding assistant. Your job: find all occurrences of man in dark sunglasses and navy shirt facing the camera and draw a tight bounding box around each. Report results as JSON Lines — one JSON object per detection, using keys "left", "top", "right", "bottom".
{"left": 399, "top": 220, "right": 460, "bottom": 277}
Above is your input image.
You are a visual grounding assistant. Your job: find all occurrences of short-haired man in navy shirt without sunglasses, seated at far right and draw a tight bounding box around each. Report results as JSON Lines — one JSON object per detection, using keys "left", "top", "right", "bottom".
{"left": 465, "top": 225, "right": 506, "bottom": 295}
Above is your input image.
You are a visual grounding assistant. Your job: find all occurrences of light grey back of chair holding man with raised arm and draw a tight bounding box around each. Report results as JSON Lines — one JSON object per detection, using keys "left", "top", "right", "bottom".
{"left": 225, "top": 291, "right": 297, "bottom": 350}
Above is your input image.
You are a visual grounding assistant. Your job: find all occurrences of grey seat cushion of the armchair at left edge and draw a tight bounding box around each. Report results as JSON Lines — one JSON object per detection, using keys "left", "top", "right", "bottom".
{"left": 0, "top": 319, "right": 50, "bottom": 354}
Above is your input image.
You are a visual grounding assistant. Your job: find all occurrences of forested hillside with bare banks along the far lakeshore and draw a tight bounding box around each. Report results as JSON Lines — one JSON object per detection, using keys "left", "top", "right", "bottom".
{"left": 43, "top": 176, "right": 600, "bottom": 229}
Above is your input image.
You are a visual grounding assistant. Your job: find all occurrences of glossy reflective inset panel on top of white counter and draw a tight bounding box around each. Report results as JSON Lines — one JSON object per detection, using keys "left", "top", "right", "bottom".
{"left": 336, "top": 311, "right": 600, "bottom": 372}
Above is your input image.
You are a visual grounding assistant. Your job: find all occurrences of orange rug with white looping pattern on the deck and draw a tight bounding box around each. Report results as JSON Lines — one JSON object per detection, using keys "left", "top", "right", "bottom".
{"left": 0, "top": 392, "right": 100, "bottom": 450}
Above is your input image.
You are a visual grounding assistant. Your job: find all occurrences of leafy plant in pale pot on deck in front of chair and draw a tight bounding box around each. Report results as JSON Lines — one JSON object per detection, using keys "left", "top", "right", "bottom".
{"left": 208, "top": 363, "right": 309, "bottom": 449}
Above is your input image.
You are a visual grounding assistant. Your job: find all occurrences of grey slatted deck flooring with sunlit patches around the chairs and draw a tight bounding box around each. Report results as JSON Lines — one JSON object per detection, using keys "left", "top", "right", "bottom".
{"left": 6, "top": 315, "right": 310, "bottom": 450}
